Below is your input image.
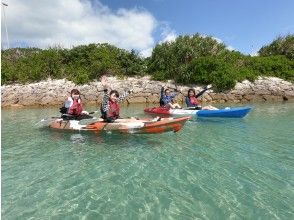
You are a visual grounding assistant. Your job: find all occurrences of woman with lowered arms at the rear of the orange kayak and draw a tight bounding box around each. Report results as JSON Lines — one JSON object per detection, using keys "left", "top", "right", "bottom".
{"left": 60, "top": 89, "right": 92, "bottom": 120}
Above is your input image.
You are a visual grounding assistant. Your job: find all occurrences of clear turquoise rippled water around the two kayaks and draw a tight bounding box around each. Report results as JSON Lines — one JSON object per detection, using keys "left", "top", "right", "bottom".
{"left": 1, "top": 103, "right": 294, "bottom": 219}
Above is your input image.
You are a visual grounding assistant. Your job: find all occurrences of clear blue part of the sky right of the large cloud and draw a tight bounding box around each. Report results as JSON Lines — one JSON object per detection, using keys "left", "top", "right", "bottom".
{"left": 101, "top": 0, "right": 294, "bottom": 54}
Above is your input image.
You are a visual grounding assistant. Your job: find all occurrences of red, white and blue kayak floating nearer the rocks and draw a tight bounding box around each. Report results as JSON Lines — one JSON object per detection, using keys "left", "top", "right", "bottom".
{"left": 144, "top": 106, "right": 251, "bottom": 118}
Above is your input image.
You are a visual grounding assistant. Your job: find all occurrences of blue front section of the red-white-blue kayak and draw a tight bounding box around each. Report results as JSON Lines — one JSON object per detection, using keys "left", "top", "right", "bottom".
{"left": 196, "top": 106, "right": 251, "bottom": 118}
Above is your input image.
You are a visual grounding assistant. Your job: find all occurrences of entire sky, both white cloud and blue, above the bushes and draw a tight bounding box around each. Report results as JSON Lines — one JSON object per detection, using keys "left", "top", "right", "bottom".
{"left": 1, "top": 0, "right": 294, "bottom": 56}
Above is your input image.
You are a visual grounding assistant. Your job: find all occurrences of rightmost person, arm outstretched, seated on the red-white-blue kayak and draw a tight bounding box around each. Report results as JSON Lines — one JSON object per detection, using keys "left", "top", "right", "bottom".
{"left": 185, "top": 86, "right": 218, "bottom": 110}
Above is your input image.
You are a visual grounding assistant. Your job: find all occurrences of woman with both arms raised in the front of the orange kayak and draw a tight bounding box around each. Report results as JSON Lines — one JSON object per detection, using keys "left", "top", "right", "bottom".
{"left": 100, "top": 76, "right": 132, "bottom": 122}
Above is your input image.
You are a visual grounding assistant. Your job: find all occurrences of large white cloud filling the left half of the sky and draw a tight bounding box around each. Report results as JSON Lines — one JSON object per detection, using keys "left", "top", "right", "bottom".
{"left": 1, "top": 0, "right": 157, "bottom": 52}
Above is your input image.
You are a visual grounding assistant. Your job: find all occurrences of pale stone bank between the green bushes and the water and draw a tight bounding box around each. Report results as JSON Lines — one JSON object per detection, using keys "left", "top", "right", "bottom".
{"left": 1, "top": 77, "right": 294, "bottom": 107}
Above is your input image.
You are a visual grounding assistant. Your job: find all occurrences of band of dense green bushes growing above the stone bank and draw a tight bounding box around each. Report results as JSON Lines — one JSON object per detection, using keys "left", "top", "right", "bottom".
{"left": 1, "top": 34, "right": 294, "bottom": 90}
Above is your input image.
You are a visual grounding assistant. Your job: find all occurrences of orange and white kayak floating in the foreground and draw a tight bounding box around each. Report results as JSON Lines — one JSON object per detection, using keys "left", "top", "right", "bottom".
{"left": 49, "top": 116, "right": 191, "bottom": 134}
